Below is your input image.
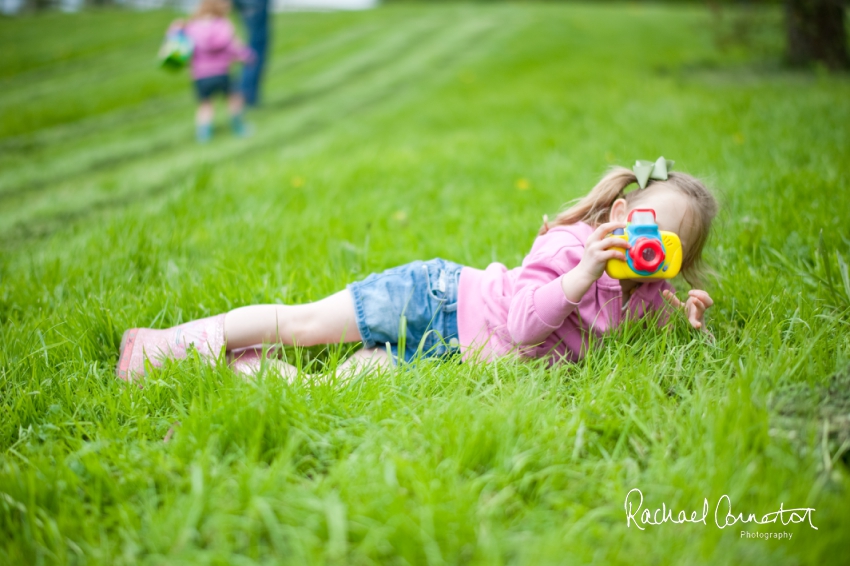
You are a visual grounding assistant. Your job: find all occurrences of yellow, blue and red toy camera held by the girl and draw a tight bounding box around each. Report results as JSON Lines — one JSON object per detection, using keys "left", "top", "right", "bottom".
{"left": 605, "top": 208, "right": 682, "bottom": 279}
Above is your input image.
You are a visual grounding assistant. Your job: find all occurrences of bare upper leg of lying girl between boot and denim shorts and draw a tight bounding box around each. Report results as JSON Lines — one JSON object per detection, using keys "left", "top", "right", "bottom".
{"left": 224, "top": 289, "right": 360, "bottom": 350}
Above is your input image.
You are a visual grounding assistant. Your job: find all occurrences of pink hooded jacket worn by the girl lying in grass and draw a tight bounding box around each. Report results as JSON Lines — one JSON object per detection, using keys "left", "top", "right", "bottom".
{"left": 458, "top": 222, "right": 672, "bottom": 361}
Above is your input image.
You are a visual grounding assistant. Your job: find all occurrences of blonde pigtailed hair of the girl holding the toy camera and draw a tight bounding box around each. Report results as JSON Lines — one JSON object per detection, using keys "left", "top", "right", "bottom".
{"left": 540, "top": 167, "right": 718, "bottom": 287}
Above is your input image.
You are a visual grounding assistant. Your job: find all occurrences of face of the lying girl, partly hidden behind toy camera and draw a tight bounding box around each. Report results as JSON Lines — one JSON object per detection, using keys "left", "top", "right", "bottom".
{"left": 611, "top": 184, "right": 694, "bottom": 260}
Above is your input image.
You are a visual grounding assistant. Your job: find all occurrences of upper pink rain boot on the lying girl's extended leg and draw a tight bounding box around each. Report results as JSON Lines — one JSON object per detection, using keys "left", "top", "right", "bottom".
{"left": 115, "top": 314, "right": 225, "bottom": 381}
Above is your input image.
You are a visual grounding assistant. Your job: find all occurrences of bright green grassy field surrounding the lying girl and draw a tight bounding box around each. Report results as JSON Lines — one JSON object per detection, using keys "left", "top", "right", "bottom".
{"left": 0, "top": 4, "right": 850, "bottom": 566}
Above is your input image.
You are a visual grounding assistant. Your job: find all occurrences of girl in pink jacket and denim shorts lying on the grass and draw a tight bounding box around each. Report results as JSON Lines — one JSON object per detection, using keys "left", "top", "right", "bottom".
{"left": 117, "top": 160, "right": 717, "bottom": 380}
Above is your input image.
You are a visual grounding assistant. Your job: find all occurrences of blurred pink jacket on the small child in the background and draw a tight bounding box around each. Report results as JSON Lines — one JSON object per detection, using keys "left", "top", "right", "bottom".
{"left": 178, "top": 18, "right": 254, "bottom": 79}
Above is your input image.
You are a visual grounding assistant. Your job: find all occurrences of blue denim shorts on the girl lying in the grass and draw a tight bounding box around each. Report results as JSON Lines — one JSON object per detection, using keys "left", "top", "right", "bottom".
{"left": 348, "top": 259, "right": 463, "bottom": 362}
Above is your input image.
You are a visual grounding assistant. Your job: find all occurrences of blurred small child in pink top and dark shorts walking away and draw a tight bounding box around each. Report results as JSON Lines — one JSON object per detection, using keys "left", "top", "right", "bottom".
{"left": 169, "top": 0, "right": 254, "bottom": 143}
